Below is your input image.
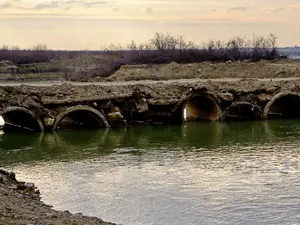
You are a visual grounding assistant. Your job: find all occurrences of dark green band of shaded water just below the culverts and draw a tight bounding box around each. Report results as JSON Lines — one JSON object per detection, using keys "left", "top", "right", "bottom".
{"left": 0, "top": 120, "right": 300, "bottom": 165}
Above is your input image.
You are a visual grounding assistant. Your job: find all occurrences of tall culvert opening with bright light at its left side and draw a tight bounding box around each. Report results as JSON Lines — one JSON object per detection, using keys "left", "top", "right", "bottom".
{"left": 182, "top": 95, "right": 220, "bottom": 122}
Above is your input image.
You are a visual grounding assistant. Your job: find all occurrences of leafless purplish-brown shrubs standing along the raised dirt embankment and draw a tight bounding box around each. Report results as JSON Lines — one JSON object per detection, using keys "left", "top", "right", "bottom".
{"left": 119, "top": 33, "right": 279, "bottom": 63}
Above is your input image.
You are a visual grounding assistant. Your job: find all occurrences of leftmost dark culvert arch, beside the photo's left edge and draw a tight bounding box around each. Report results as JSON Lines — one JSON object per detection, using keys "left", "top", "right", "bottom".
{"left": 0, "top": 106, "right": 44, "bottom": 131}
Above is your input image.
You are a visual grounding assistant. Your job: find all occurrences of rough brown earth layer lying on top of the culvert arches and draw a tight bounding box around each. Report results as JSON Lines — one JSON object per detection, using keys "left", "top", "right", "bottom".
{"left": 0, "top": 78, "right": 300, "bottom": 108}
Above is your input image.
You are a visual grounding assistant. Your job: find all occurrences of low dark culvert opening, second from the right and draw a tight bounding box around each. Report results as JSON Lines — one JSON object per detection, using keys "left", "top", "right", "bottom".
{"left": 221, "top": 102, "right": 262, "bottom": 121}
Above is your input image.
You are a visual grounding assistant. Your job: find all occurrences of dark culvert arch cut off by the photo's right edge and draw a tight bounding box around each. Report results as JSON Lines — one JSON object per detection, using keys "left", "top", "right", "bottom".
{"left": 263, "top": 92, "right": 300, "bottom": 119}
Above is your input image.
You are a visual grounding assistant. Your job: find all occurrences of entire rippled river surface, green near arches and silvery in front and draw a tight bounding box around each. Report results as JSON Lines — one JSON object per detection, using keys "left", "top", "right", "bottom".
{"left": 0, "top": 120, "right": 300, "bottom": 225}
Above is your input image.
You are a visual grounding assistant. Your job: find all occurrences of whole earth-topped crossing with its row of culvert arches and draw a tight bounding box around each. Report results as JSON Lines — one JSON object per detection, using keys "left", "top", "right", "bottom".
{"left": 0, "top": 78, "right": 300, "bottom": 131}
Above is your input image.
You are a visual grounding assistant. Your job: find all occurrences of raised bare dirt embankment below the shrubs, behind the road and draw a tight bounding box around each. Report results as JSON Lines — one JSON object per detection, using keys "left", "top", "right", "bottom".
{"left": 105, "top": 59, "right": 300, "bottom": 81}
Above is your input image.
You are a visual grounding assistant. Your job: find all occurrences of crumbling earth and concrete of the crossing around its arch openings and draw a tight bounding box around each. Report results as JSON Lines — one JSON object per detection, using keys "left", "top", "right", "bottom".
{"left": 0, "top": 78, "right": 300, "bottom": 132}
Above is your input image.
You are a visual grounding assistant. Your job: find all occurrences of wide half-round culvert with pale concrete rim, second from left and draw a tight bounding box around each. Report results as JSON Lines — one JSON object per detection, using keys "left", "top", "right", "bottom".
{"left": 52, "top": 105, "right": 110, "bottom": 130}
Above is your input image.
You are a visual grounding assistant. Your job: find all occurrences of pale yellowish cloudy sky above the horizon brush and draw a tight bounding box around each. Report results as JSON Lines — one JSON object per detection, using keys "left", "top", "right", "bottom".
{"left": 0, "top": 0, "right": 300, "bottom": 49}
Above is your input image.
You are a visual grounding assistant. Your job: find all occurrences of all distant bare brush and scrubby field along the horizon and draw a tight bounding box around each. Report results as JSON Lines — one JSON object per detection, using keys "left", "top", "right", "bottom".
{"left": 0, "top": 33, "right": 279, "bottom": 81}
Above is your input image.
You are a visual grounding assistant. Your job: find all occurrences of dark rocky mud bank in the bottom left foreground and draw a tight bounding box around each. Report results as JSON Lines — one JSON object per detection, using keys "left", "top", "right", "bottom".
{"left": 0, "top": 169, "right": 114, "bottom": 225}
